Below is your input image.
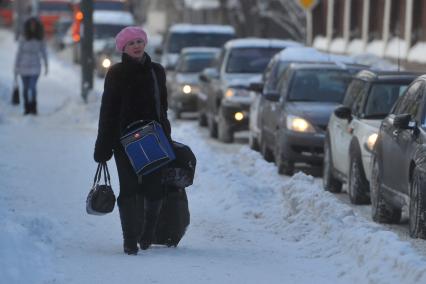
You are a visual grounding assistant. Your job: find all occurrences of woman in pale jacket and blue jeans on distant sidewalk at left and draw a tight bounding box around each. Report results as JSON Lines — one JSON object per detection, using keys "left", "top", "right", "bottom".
{"left": 14, "top": 18, "right": 48, "bottom": 115}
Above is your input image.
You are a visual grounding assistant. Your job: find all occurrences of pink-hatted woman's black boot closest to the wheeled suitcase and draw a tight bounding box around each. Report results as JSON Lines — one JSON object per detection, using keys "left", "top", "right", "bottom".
{"left": 139, "top": 198, "right": 163, "bottom": 250}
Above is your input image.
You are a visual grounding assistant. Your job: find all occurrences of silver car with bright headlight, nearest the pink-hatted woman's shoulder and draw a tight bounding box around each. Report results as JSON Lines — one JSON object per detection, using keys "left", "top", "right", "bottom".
{"left": 168, "top": 47, "right": 220, "bottom": 118}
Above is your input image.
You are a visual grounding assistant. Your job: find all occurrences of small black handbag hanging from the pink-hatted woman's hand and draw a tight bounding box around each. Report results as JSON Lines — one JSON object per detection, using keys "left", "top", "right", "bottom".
{"left": 86, "top": 163, "right": 115, "bottom": 215}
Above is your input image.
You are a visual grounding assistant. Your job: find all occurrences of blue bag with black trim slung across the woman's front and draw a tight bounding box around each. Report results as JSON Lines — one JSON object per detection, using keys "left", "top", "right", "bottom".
{"left": 120, "top": 121, "right": 176, "bottom": 175}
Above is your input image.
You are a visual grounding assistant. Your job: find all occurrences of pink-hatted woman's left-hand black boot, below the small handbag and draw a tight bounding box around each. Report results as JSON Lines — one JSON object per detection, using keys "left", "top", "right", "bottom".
{"left": 117, "top": 197, "right": 139, "bottom": 255}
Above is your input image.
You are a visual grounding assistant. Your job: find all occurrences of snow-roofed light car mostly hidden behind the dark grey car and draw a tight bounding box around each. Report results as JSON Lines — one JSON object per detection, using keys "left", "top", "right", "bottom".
{"left": 249, "top": 46, "right": 354, "bottom": 151}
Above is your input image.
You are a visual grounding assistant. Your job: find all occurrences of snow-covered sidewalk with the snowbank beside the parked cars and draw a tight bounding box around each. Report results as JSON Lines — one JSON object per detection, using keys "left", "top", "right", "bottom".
{"left": 0, "top": 27, "right": 426, "bottom": 284}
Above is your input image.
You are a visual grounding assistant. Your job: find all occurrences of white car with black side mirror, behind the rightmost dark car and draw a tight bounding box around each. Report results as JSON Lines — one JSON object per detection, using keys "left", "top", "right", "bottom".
{"left": 323, "top": 70, "right": 417, "bottom": 204}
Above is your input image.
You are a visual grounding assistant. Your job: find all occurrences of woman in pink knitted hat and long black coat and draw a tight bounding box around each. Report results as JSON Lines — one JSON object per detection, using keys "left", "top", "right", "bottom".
{"left": 94, "top": 27, "right": 171, "bottom": 254}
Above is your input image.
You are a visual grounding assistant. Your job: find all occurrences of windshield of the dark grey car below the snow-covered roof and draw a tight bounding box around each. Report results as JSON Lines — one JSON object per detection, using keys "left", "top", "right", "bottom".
{"left": 288, "top": 69, "right": 355, "bottom": 103}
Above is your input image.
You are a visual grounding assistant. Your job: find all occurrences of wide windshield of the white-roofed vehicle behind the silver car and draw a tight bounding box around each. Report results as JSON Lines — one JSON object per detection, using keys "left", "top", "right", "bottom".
{"left": 168, "top": 32, "right": 234, "bottom": 53}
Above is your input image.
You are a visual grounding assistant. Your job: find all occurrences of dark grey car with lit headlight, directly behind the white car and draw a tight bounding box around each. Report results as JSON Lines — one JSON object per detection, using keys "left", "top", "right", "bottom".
{"left": 261, "top": 62, "right": 365, "bottom": 175}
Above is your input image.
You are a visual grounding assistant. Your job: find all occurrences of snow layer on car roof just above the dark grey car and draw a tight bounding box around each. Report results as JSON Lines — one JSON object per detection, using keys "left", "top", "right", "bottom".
{"left": 275, "top": 46, "right": 355, "bottom": 63}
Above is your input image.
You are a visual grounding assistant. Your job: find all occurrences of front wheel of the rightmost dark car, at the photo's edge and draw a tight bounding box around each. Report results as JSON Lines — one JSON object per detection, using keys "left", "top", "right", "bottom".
{"left": 409, "top": 167, "right": 426, "bottom": 239}
